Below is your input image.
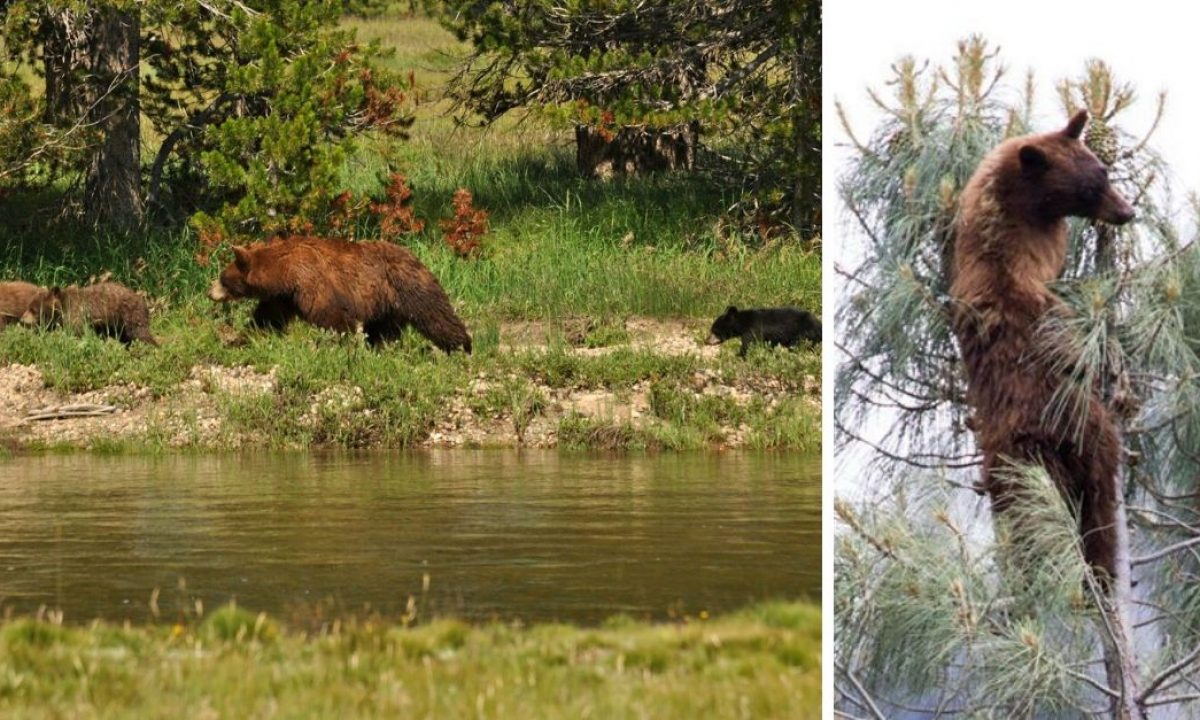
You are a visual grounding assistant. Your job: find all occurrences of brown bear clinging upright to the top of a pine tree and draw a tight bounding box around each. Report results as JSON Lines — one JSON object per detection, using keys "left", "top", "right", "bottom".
{"left": 950, "top": 110, "right": 1134, "bottom": 578}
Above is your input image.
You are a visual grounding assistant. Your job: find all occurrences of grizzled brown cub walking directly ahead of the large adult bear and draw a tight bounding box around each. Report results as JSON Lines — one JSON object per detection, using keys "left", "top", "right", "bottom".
{"left": 22, "top": 282, "right": 158, "bottom": 346}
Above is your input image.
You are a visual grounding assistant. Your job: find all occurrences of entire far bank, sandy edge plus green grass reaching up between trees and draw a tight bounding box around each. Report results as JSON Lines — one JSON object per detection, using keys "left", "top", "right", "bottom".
{"left": 0, "top": 16, "right": 821, "bottom": 450}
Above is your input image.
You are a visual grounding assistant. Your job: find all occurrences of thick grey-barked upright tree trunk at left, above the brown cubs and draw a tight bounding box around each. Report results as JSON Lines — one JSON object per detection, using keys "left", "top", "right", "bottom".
{"left": 84, "top": 6, "right": 143, "bottom": 230}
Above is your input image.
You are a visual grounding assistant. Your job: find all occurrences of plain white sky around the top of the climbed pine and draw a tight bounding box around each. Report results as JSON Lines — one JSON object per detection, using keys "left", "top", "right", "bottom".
{"left": 822, "top": 0, "right": 1200, "bottom": 494}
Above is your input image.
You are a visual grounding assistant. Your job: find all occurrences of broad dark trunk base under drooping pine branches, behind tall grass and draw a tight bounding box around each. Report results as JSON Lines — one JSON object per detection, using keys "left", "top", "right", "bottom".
{"left": 575, "top": 122, "right": 700, "bottom": 180}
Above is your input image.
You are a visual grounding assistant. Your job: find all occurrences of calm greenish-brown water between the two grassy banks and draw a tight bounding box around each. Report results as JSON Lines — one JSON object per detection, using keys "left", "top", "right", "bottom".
{"left": 0, "top": 450, "right": 821, "bottom": 623}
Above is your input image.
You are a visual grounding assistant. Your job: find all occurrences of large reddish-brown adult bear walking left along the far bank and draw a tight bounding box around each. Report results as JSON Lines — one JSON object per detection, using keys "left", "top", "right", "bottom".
{"left": 209, "top": 236, "right": 470, "bottom": 354}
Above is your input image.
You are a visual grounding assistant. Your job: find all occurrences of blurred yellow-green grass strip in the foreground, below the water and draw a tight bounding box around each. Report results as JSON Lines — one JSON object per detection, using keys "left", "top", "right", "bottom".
{"left": 0, "top": 604, "right": 821, "bottom": 720}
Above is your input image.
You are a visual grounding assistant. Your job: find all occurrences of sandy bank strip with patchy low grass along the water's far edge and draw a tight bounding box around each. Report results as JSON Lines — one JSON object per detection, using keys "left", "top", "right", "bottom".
{"left": 0, "top": 318, "right": 821, "bottom": 451}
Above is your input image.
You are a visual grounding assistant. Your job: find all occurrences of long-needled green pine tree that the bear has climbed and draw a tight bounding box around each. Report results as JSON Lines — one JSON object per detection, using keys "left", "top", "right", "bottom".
{"left": 834, "top": 37, "right": 1200, "bottom": 718}
